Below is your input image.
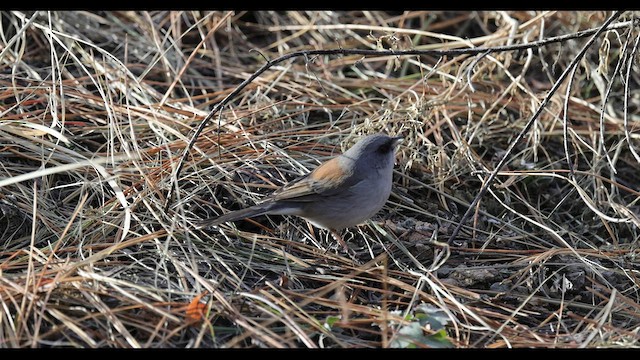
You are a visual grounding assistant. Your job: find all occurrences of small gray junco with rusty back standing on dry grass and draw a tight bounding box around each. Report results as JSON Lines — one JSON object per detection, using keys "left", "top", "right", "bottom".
{"left": 198, "top": 134, "right": 402, "bottom": 251}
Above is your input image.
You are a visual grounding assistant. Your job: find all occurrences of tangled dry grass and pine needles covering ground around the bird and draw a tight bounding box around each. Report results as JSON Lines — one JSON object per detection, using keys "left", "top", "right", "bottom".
{"left": 0, "top": 11, "right": 640, "bottom": 348}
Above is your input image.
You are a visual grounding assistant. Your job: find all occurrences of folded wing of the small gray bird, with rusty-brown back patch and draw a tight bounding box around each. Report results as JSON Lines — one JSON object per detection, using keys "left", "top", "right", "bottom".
{"left": 270, "top": 157, "right": 359, "bottom": 202}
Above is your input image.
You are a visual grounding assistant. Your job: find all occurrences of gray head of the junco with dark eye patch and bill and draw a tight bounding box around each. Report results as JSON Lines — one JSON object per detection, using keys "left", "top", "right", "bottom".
{"left": 343, "top": 133, "right": 402, "bottom": 169}
